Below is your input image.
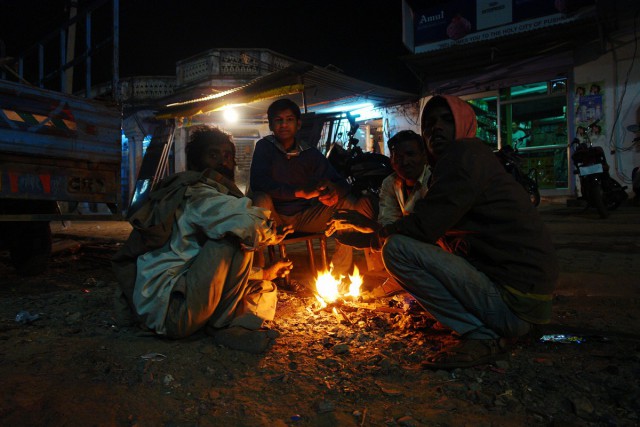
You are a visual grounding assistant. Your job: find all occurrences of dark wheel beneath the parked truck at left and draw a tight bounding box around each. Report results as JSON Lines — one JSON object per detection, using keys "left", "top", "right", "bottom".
{"left": 9, "top": 222, "right": 51, "bottom": 276}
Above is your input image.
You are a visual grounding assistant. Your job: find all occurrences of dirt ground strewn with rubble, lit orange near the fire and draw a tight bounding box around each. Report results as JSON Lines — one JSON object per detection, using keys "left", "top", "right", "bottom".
{"left": 0, "top": 205, "right": 640, "bottom": 426}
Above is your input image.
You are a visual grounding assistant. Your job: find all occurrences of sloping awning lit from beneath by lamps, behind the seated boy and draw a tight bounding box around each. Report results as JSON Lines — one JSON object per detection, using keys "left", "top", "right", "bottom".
{"left": 156, "top": 62, "right": 419, "bottom": 119}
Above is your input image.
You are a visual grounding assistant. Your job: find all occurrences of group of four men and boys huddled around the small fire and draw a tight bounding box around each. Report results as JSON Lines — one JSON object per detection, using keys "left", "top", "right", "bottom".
{"left": 113, "top": 95, "right": 558, "bottom": 369}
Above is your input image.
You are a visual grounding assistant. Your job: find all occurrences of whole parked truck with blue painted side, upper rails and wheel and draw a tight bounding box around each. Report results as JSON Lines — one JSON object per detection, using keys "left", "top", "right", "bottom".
{"left": 0, "top": 0, "right": 122, "bottom": 275}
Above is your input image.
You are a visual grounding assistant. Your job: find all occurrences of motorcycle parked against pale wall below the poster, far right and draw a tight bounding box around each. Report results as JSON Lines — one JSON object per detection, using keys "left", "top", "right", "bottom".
{"left": 570, "top": 120, "right": 628, "bottom": 218}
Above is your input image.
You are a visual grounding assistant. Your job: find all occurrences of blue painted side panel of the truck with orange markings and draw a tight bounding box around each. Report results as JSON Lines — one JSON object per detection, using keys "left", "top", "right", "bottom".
{"left": 0, "top": 80, "right": 122, "bottom": 213}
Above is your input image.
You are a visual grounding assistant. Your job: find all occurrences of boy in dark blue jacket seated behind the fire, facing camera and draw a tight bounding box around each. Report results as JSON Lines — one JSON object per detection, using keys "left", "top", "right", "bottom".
{"left": 250, "top": 99, "right": 374, "bottom": 275}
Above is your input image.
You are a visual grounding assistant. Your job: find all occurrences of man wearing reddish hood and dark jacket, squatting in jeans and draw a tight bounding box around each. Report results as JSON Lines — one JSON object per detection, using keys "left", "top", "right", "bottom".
{"left": 328, "top": 95, "right": 558, "bottom": 369}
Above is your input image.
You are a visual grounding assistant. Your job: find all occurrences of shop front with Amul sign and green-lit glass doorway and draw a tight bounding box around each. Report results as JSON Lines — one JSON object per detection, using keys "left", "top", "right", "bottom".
{"left": 404, "top": 0, "right": 640, "bottom": 199}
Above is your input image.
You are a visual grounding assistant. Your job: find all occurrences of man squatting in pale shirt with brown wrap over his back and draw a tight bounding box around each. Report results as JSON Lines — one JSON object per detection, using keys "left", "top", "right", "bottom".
{"left": 114, "top": 126, "right": 291, "bottom": 353}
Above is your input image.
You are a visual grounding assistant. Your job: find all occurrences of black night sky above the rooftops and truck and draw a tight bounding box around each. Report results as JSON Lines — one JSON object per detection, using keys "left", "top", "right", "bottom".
{"left": 0, "top": 0, "right": 417, "bottom": 90}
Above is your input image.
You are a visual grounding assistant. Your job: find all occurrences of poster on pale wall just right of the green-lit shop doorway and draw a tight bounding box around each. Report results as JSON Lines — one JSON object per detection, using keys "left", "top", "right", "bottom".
{"left": 575, "top": 81, "right": 606, "bottom": 148}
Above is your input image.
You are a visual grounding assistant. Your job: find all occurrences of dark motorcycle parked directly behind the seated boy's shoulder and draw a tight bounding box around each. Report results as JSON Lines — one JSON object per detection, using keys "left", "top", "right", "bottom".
{"left": 326, "top": 116, "right": 393, "bottom": 197}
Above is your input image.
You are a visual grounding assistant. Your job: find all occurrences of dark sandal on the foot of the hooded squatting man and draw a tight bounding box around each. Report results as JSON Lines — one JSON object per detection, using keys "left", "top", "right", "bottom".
{"left": 422, "top": 338, "right": 507, "bottom": 369}
